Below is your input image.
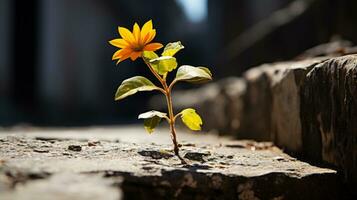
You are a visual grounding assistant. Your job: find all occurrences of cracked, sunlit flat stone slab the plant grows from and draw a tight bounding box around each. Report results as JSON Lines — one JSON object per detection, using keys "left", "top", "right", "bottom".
{"left": 0, "top": 127, "right": 345, "bottom": 199}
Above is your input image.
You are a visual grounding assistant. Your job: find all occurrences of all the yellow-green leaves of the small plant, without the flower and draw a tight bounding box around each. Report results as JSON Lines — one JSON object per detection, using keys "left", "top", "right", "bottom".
{"left": 115, "top": 41, "right": 212, "bottom": 134}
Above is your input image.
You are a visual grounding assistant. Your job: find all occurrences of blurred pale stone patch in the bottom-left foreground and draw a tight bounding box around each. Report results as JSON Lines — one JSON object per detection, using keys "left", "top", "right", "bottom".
{"left": 0, "top": 172, "right": 122, "bottom": 200}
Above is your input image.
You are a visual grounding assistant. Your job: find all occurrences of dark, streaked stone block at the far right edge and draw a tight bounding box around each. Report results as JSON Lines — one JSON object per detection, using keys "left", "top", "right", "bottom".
{"left": 301, "top": 55, "right": 357, "bottom": 184}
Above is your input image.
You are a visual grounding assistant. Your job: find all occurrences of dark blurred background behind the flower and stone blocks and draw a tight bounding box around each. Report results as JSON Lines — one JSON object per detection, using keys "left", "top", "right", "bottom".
{"left": 0, "top": 0, "right": 357, "bottom": 126}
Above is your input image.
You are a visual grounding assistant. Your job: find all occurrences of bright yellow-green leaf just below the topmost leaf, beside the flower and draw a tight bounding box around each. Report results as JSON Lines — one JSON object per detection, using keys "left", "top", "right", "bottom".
{"left": 150, "top": 56, "right": 177, "bottom": 75}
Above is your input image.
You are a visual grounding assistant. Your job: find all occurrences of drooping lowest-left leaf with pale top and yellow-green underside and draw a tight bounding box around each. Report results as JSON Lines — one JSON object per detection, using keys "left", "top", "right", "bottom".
{"left": 138, "top": 110, "right": 167, "bottom": 134}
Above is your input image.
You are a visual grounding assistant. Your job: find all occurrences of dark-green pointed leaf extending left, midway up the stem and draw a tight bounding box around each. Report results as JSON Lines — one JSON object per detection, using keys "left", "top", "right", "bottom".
{"left": 115, "top": 76, "right": 160, "bottom": 101}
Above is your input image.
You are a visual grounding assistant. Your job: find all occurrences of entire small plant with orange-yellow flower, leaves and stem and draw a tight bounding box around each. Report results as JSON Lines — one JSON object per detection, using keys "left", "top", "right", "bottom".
{"left": 109, "top": 20, "right": 212, "bottom": 163}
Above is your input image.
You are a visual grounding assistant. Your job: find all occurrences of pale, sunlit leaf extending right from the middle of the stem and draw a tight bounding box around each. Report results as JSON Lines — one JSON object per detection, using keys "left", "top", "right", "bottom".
{"left": 175, "top": 65, "right": 212, "bottom": 83}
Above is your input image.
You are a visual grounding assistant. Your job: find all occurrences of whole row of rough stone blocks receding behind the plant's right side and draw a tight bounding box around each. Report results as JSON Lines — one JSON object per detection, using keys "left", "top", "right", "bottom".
{"left": 161, "top": 55, "right": 357, "bottom": 185}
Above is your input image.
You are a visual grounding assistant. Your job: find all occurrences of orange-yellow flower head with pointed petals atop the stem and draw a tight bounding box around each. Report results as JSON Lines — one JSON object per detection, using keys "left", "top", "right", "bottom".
{"left": 109, "top": 20, "right": 163, "bottom": 64}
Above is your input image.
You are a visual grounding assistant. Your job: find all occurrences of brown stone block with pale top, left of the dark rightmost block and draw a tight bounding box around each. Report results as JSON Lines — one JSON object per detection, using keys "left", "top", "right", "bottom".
{"left": 243, "top": 58, "right": 326, "bottom": 148}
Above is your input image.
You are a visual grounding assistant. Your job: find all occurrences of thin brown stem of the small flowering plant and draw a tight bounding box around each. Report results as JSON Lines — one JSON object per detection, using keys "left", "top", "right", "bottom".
{"left": 145, "top": 62, "right": 187, "bottom": 164}
